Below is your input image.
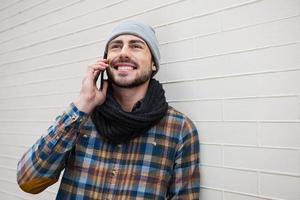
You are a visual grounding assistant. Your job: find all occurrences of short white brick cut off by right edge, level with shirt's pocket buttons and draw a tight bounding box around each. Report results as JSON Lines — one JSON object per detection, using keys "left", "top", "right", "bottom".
{"left": 259, "top": 123, "right": 300, "bottom": 148}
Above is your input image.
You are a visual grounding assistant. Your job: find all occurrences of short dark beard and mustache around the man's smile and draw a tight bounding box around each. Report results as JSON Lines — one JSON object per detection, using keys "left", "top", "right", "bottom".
{"left": 107, "top": 58, "right": 152, "bottom": 88}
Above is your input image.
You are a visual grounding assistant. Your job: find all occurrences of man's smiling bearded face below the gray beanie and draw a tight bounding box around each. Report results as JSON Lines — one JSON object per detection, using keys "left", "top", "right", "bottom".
{"left": 108, "top": 35, "right": 156, "bottom": 88}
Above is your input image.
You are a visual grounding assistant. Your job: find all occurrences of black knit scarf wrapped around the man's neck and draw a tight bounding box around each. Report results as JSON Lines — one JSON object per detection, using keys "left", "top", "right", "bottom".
{"left": 91, "top": 79, "right": 168, "bottom": 144}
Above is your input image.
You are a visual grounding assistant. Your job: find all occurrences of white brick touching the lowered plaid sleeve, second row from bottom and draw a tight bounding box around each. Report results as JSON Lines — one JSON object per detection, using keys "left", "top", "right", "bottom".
{"left": 201, "top": 166, "right": 258, "bottom": 194}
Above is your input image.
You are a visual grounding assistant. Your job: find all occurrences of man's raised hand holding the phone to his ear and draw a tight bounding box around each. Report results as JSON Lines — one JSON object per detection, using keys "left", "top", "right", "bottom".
{"left": 74, "top": 59, "right": 108, "bottom": 114}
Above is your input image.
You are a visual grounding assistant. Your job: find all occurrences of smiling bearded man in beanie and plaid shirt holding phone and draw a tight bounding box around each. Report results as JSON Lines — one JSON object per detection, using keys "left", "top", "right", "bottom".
{"left": 17, "top": 21, "right": 200, "bottom": 200}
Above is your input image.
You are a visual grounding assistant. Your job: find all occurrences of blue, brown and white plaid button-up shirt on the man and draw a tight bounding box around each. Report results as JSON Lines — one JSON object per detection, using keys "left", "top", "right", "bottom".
{"left": 17, "top": 104, "right": 200, "bottom": 200}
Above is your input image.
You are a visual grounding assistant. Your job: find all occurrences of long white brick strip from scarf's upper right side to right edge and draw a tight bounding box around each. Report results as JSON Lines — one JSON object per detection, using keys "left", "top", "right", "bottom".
{"left": 163, "top": 71, "right": 300, "bottom": 100}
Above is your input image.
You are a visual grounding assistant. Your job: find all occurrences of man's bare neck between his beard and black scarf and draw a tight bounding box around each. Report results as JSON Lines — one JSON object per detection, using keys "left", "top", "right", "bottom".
{"left": 113, "top": 81, "right": 149, "bottom": 112}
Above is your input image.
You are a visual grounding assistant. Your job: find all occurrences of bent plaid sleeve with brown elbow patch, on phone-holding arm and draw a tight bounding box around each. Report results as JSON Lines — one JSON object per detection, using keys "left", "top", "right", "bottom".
{"left": 17, "top": 103, "right": 87, "bottom": 194}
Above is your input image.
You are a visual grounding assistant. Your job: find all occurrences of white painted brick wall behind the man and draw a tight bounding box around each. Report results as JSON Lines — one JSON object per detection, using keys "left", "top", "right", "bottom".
{"left": 0, "top": 0, "right": 300, "bottom": 200}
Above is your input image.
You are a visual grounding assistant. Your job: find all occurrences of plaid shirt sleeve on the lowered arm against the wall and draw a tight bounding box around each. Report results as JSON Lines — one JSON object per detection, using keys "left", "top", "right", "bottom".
{"left": 168, "top": 120, "right": 200, "bottom": 200}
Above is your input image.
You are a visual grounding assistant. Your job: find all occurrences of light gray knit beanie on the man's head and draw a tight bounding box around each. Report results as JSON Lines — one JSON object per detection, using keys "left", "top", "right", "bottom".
{"left": 104, "top": 20, "right": 160, "bottom": 76}
